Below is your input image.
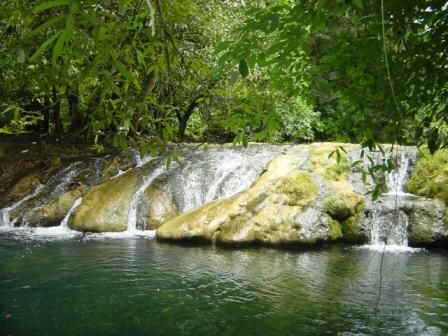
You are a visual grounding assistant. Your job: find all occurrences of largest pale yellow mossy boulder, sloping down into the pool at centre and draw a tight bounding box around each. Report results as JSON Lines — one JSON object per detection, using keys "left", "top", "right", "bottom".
{"left": 157, "top": 148, "right": 338, "bottom": 245}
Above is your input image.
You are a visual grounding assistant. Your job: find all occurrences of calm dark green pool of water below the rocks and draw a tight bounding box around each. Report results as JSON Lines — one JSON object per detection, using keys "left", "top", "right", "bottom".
{"left": 0, "top": 234, "right": 448, "bottom": 335}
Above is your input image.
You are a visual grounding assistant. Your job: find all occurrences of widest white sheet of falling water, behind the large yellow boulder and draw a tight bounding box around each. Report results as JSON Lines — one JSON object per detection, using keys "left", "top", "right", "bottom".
{"left": 167, "top": 145, "right": 282, "bottom": 213}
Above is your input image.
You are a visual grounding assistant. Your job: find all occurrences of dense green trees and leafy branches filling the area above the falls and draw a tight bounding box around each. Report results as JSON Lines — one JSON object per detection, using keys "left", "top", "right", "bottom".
{"left": 0, "top": 0, "right": 448, "bottom": 151}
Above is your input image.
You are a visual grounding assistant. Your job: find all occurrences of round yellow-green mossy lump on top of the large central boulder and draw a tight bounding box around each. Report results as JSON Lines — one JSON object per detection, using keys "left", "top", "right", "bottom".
{"left": 276, "top": 172, "right": 318, "bottom": 207}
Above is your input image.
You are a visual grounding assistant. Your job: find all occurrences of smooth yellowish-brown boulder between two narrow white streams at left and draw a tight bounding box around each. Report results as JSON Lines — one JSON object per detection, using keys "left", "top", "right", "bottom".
{"left": 69, "top": 169, "right": 141, "bottom": 232}
